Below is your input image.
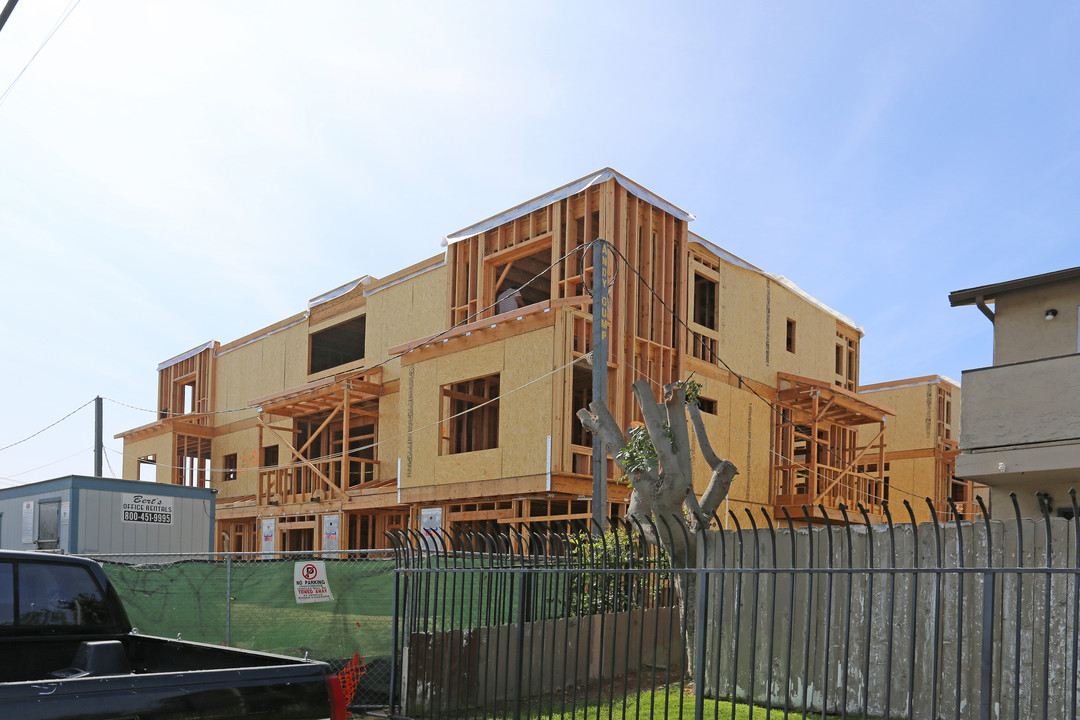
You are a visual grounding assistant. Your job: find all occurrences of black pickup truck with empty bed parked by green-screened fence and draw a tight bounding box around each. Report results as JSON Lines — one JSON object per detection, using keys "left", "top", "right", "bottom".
{"left": 0, "top": 551, "right": 348, "bottom": 720}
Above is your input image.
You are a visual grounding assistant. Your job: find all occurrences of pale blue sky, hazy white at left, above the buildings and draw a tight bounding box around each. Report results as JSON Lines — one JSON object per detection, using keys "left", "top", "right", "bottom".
{"left": 0, "top": 0, "right": 1080, "bottom": 487}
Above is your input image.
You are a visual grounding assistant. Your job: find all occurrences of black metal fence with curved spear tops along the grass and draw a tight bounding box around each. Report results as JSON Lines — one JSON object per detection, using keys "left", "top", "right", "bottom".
{"left": 389, "top": 493, "right": 1080, "bottom": 720}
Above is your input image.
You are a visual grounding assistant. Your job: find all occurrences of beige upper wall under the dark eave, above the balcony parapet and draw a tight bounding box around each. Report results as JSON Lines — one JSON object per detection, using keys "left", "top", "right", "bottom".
{"left": 994, "top": 282, "right": 1080, "bottom": 365}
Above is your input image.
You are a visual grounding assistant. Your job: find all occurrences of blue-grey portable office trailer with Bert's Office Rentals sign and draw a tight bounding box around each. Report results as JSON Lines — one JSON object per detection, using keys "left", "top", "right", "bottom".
{"left": 0, "top": 475, "right": 215, "bottom": 555}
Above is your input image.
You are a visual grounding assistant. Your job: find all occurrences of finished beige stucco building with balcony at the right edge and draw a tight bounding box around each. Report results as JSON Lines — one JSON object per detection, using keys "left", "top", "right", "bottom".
{"left": 949, "top": 268, "right": 1080, "bottom": 516}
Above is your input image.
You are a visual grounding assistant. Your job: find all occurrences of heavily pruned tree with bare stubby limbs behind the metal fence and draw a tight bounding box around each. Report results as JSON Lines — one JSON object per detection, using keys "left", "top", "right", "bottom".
{"left": 578, "top": 380, "right": 739, "bottom": 667}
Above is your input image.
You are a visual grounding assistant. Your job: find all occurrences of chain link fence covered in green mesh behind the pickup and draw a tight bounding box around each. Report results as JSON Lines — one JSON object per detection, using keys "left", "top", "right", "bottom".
{"left": 94, "top": 551, "right": 394, "bottom": 706}
